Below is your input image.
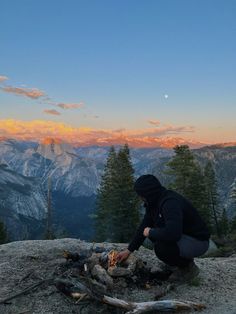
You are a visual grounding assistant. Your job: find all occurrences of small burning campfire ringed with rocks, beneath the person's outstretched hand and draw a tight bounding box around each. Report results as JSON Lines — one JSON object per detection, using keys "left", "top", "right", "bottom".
{"left": 63, "top": 248, "right": 167, "bottom": 291}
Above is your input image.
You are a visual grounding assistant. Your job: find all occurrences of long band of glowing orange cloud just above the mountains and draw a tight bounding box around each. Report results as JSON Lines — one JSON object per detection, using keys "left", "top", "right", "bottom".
{"left": 0, "top": 119, "right": 204, "bottom": 148}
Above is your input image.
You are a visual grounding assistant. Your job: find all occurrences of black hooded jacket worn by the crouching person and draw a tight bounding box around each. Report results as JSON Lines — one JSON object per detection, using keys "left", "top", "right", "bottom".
{"left": 128, "top": 175, "right": 210, "bottom": 252}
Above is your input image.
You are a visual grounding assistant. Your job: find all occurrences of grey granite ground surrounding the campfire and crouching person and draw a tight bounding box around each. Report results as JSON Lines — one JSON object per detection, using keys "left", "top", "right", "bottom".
{"left": 0, "top": 239, "right": 236, "bottom": 314}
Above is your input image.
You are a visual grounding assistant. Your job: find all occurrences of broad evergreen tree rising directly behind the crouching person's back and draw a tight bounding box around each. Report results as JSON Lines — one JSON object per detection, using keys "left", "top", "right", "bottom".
{"left": 166, "top": 145, "right": 209, "bottom": 222}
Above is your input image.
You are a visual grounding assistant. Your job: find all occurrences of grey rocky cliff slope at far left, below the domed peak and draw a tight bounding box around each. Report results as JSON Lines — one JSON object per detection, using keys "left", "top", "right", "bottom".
{"left": 0, "top": 165, "right": 47, "bottom": 239}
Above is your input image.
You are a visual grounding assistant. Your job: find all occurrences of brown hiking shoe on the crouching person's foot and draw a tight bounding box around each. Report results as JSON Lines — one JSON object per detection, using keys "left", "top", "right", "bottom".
{"left": 168, "top": 262, "right": 199, "bottom": 282}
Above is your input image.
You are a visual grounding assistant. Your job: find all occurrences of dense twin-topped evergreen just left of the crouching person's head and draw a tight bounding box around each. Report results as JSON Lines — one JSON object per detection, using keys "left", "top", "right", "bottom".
{"left": 95, "top": 145, "right": 139, "bottom": 242}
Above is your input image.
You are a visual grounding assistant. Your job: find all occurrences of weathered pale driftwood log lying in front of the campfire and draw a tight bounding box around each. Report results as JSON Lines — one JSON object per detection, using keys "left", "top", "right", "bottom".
{"left": 56, "top": 280, "right": 205, "bottom": 314}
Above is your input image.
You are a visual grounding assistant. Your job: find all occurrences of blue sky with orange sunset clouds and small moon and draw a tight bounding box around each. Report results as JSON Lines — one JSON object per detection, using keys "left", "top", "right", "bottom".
{"left": 0, "top": 0, "right": 236, "bottom": 147}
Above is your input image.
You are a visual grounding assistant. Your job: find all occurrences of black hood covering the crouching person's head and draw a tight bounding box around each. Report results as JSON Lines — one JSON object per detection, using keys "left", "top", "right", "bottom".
{"left": 134, "top": 174, "right": 163, "bottom": 199}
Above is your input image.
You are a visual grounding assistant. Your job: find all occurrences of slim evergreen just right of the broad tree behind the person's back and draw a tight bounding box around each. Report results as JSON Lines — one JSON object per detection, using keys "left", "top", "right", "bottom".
{"left": 204, "top": 161, "right": 221, "bottom": 236}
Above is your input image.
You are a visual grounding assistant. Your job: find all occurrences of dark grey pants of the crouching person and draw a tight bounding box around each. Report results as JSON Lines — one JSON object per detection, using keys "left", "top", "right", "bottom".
{"left": 154, "top": 234, "right": 209, "bottom": 267}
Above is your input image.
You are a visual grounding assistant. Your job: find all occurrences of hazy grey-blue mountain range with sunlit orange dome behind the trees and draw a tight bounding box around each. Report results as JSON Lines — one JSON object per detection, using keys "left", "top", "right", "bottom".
{"left": 0, "top": 139, "right": 236, "bottom": 239}
